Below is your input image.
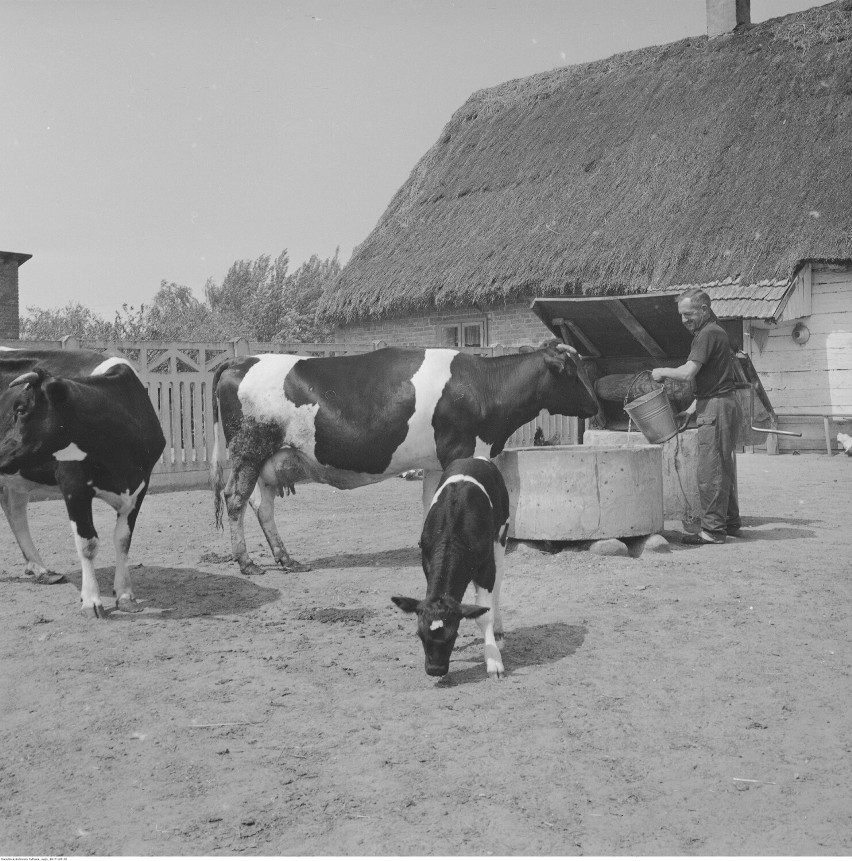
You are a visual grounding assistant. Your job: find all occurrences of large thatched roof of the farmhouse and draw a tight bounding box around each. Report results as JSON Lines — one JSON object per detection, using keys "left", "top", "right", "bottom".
{"left": 320, "top": 0, "right": 852, "bottom": 323}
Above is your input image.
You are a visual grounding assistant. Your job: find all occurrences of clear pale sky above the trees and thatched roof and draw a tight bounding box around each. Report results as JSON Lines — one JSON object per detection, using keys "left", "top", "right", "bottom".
{"left": 0, "top": 0, "right": 825, "bottom": 317}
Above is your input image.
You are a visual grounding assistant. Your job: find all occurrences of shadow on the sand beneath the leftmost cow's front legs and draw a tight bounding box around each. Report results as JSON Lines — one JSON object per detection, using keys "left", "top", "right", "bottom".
{"left": 64, "top": 565, "right": 281, "bottom": 621}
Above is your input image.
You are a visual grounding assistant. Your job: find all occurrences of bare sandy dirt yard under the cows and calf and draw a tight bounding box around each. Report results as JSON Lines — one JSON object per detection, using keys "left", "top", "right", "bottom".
{"left": 0, "top": 454, "right": 852, "bottom": 855}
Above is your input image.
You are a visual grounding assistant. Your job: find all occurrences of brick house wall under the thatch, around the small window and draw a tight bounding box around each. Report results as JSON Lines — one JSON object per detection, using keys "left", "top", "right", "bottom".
{"left": 335, "top": 303, "right": 553, "bottom": 347}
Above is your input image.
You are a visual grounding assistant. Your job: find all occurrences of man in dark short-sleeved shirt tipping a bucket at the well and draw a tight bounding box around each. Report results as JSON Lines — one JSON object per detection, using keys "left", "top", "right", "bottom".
{"left": 651, "top": 287, "right": 742, "bottom": 545}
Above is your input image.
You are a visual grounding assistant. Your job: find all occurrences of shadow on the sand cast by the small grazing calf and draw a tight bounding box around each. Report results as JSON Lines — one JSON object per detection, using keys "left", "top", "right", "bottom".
{"left": 435, "top": 622, "right": 588, "bottom": 685}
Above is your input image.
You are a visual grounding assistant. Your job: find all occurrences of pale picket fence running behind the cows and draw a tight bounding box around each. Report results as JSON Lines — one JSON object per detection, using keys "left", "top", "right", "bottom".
{"left": 0, "top": 337, "right": 577, "bottom": 490}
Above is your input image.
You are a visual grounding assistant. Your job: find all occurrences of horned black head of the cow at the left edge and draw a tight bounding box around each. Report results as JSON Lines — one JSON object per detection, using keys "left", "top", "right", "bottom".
{"left": 0, "top": 368, "right": 71, "bottom": 473}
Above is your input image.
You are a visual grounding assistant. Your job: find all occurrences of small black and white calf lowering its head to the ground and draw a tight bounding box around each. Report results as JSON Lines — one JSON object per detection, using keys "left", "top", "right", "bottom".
{"left": 391, "top": 457, "right": 509, "bottom": 679}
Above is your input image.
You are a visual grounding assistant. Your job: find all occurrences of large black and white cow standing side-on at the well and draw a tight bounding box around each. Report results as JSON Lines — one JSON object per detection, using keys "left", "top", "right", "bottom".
{"left": 212, "top": 342, "right": 598, "bottom": 574}
